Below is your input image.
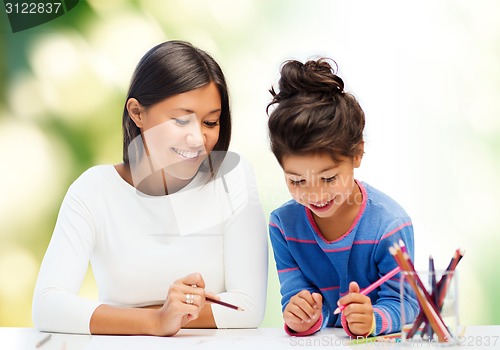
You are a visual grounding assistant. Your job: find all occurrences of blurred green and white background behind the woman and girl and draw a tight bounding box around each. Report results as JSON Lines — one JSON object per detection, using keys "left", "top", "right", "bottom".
{"left": 0, "top": 0, "right": 500, "bottom": 327}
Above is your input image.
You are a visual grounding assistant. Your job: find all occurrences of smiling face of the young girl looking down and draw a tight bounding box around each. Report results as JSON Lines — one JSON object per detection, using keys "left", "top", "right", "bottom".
{"left": 282, "top": 153, "right": 361, "bottom": 218}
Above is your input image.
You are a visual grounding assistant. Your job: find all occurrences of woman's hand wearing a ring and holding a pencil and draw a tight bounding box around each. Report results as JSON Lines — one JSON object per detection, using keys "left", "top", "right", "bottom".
{"left": 157, "top": 273, "right": 209, "bottom": 336}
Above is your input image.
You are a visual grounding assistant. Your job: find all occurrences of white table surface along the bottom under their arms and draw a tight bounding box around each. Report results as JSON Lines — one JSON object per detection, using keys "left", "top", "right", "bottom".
{"left": 0, "top": 325, "right": 500, "bottom": 350}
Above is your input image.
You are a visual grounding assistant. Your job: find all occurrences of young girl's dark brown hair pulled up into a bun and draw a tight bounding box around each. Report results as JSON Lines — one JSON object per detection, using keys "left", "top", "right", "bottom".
{"left": 266, "top": 58, "right": 365, "bottom": 164}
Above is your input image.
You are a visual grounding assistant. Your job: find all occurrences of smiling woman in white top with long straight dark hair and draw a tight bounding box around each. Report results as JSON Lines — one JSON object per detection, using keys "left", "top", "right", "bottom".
{"left": 33, "top": 41, "right": 267, "bottom": 336}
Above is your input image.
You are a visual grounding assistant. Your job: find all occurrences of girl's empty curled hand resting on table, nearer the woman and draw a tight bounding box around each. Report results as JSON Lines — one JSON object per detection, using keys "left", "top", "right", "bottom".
{"left": 283, "top": 290, "right": 323, "bottom": 333}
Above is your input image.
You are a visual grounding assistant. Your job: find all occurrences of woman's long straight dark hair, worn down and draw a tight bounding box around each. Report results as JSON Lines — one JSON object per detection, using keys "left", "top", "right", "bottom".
{"left": 122, "top": 40, "right": 231, "bottom": 164}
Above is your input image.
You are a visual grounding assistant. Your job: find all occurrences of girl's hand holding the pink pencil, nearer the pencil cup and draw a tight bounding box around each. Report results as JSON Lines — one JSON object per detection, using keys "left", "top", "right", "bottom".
{"left": 337, "top": 282, "right": 373, "bottom": 336}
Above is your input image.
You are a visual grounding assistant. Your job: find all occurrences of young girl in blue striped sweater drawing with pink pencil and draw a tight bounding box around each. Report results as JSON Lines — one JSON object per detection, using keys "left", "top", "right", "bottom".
{"left": 267, "top": 59, "right": 418, "bottom": 336}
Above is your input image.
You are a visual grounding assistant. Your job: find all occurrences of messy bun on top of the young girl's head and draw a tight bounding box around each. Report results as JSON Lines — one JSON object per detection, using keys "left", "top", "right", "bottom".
{"left": 271, "top": 58, "right": 344, "bottom": 100}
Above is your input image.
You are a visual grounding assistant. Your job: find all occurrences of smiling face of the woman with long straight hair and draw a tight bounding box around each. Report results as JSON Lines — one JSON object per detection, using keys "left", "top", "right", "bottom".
{"left": 136, "top": 83, "right": 221, "bottom": 180}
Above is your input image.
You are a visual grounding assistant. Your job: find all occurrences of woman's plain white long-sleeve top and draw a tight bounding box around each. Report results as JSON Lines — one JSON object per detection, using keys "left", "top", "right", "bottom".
{"left": 33, "top": 153, "right": 268, "bottom": 334}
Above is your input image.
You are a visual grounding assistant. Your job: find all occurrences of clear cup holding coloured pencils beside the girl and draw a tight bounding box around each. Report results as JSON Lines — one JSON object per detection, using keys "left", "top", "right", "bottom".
{"left": 400, "top": 270, "right": 460, "bottom": 346}
